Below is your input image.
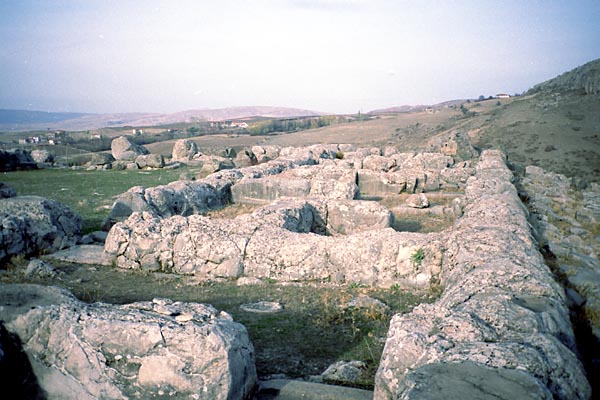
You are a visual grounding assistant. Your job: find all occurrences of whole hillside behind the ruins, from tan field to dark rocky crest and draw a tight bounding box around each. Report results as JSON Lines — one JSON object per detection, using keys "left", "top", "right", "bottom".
{"left": 300, "top": 60, "right": 600, "bottom": 182}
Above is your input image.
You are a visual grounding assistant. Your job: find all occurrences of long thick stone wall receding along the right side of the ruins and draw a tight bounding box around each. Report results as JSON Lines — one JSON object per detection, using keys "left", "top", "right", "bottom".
{"left": 375, "top": 151, "right": 591, "bottom": 399}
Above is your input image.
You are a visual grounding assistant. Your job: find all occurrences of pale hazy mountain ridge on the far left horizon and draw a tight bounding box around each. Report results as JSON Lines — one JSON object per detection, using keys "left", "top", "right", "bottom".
{"left": 0, "top": 106, "right": 324, "bottom": 132}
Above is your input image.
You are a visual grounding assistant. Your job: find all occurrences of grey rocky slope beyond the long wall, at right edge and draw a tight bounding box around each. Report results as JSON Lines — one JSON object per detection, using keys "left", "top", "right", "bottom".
{"left": 520, "top": 166, "right": 600, "bottom": 376}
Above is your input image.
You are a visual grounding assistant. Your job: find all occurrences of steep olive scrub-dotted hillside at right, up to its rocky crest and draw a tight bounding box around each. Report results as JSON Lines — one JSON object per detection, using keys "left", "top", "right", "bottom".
{"left": 424, "top": 60, "right": 600, "bottom": 182}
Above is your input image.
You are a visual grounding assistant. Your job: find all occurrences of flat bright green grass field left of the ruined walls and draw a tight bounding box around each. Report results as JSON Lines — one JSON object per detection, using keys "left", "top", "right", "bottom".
{"left": 0, "top": 167, "right": 194, "bottom": 233}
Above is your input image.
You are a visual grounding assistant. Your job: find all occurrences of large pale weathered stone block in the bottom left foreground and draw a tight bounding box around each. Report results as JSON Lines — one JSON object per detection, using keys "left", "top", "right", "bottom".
{"left": 0, "top": 285, "right": 256, "bottom": 400}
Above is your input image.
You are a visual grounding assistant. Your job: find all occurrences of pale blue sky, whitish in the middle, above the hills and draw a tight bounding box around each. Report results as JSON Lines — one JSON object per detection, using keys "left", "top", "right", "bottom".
{"left": 0, "top": 0, "right": 600, "bottom": 113}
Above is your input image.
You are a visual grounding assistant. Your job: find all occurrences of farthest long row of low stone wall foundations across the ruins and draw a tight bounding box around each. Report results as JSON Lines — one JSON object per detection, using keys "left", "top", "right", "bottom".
{"left": 103, "top": 145, "right": 473, "bottom": 230}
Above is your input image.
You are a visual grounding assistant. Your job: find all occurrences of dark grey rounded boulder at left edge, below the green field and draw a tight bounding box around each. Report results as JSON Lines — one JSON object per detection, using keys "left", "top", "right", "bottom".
{"left": 0, "top": 196, "right": 82, "bottom": 260}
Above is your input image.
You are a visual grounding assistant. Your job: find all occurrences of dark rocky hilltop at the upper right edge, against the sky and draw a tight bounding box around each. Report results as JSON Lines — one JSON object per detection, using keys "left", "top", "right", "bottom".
{"left": 527, "top": 59, "right": 600, "bottom": 94}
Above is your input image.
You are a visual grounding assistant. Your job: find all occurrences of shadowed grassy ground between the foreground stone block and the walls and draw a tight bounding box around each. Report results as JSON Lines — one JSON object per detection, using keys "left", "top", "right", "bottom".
{"left": 0, "top": 261, "right": 439, "bottom": 388}
